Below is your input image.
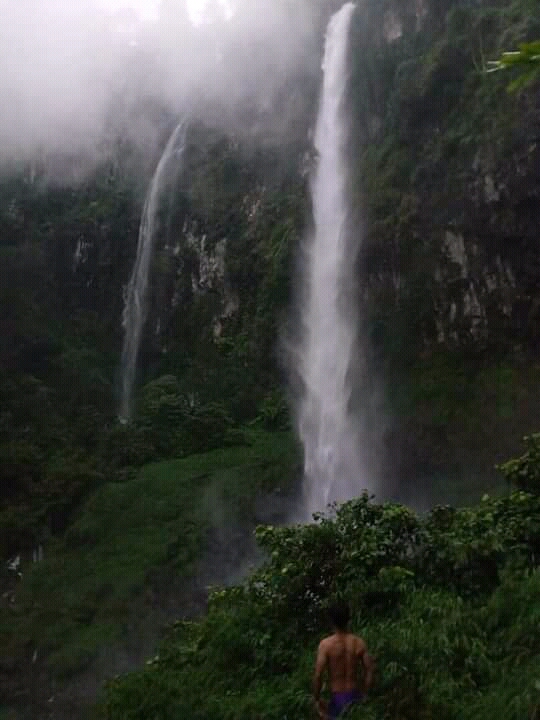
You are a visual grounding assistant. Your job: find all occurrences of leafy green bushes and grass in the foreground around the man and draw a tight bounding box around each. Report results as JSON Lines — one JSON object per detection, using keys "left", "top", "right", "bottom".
{"left": 101, "top": 444, "right": 540, "bottom": 720}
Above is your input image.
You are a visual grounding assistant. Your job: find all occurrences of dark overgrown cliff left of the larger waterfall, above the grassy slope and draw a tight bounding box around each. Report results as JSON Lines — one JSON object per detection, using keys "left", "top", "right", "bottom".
{"left": 0, "top": 118, "right": 305, "bottom": 559}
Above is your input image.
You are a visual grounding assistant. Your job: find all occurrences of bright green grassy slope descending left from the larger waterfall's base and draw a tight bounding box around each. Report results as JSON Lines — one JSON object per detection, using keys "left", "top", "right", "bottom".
{"left": 0, "top": 433, "right": 298, "bottom": 716}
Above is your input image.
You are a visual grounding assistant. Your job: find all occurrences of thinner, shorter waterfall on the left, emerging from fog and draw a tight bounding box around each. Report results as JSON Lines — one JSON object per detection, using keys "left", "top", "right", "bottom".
{"left": 119, "top": 120, "right": 187, "bottom": 422}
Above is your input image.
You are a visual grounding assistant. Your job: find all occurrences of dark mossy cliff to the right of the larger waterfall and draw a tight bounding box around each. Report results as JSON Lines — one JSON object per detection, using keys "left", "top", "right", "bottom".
{"left": 350, "top": 0, "right": 540, "bottom": 496}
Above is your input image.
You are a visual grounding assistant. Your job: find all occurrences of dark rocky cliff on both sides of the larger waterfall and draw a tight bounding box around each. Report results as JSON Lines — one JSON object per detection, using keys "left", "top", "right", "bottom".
{"left": 137, "top": 0, "right": 540, "bottom": 496}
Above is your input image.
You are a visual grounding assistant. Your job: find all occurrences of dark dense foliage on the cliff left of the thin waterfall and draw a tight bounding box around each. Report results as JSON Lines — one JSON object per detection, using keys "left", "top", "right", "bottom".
{"left": 0, "top": 167, "right": 138, "bottom": 558}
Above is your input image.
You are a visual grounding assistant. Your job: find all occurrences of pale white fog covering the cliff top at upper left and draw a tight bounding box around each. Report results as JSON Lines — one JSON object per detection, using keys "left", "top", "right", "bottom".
{"left": 0, "top": 0, "right": 332, "bottom": 167}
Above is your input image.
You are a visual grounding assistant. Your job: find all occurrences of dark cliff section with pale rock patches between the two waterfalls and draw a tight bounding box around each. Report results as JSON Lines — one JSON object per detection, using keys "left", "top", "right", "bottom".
{"left": 136, "top": 121, "right": 310, "bottom": 419}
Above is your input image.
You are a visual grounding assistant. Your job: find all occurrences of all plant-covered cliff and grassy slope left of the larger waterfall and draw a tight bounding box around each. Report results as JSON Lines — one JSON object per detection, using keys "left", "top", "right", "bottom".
{"left": 0, "top": 102, "right": 307, "bottom": 717}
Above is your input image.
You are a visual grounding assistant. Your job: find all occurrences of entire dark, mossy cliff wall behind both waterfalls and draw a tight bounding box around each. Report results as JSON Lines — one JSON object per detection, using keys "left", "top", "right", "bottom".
{"left": 0, "top": 0, "right": 540, "bottom": 506}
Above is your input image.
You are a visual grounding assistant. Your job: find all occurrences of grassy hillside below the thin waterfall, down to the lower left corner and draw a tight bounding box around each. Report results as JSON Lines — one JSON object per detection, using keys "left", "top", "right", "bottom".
{"left": 0, "top": 431, "right": 299, "bottom": 720}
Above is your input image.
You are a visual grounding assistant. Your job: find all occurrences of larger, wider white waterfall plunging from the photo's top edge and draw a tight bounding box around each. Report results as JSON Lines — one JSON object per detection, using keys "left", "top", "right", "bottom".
{"left": 298, "top": 2, "right": 363, "bottom": 516}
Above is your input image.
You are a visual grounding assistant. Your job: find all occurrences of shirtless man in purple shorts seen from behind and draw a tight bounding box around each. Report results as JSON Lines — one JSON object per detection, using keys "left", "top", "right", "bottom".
{"left": 313, "top": 605, "right": 373, "bottom": 720}
